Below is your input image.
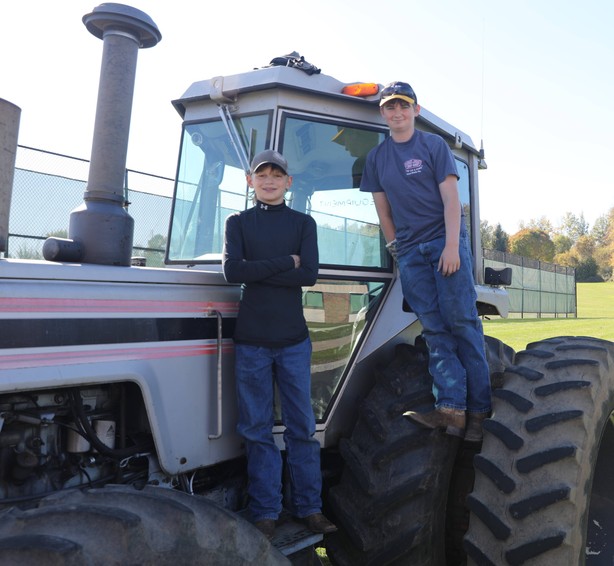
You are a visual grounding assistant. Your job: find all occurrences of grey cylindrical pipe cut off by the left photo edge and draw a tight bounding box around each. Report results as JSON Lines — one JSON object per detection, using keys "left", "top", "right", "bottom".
{"left": 0, "top": 98, "right": 21, "bottom": 252}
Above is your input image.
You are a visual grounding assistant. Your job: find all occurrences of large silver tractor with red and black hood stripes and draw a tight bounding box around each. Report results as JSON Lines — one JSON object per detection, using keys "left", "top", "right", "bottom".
{"left": 0, "top": 3, "right": 614, "bottom": 566}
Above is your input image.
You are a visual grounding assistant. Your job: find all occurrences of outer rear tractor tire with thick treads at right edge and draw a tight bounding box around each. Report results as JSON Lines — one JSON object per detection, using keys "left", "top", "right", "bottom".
{"left": 465, "top": 337, "right": 614, "bottom": 566}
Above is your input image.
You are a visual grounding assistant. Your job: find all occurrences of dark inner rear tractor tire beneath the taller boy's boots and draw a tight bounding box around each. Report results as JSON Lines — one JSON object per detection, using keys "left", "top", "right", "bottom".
{"left": 325, "top": 344, "right": 459, "bottom": 566}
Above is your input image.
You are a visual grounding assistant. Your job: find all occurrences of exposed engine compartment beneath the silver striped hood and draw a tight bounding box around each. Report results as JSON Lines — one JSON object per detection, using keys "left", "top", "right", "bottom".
{"left": 0, "top": 383, "right": 153, "bottom": 506}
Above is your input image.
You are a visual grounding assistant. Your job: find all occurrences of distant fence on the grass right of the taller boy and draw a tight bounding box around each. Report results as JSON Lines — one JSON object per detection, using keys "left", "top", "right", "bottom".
{"left": 482, "top": 250, "right": 578, "bottom": 317}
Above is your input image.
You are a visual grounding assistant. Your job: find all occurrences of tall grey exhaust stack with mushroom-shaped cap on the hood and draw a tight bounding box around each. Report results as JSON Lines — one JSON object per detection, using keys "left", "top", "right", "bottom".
{"left": 43, "top": 3, "right": 162, "bottom": 266}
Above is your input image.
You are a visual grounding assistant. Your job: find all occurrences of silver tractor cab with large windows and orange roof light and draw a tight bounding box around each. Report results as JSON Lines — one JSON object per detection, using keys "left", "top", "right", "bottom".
{"left": 166, "top": 62, "right": 508, "bottom": 437}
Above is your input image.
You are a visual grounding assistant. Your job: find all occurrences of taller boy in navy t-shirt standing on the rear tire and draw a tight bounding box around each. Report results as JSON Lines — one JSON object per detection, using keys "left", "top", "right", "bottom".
{"left": 360, "top": 82, "right": 491, "bottom": 442}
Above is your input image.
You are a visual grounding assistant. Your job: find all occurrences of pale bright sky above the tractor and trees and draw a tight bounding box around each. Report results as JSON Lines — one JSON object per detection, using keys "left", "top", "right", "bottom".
{"left": 0, "top": 0, "right": 614, "bottom": 235}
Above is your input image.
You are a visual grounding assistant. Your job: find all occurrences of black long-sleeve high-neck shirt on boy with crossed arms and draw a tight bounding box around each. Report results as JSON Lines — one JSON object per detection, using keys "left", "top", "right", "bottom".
{"left": 223, "top": 202, "right": 319, "bottom": 348}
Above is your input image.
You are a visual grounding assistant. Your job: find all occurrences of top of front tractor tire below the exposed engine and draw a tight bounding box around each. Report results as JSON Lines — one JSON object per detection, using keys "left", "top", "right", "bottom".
{"left": 0, "top": 485, "right": 290, "bottom": 566}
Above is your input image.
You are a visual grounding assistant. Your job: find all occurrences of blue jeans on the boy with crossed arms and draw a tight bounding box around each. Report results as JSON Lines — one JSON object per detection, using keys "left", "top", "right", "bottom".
{"left": 235, "top": 338, "right": 322, "bottom": 521}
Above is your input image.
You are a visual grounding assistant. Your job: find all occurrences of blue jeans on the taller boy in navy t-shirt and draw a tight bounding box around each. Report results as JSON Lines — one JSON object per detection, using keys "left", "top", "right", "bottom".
{"left": 398, "top": 236, "right": 491, "bottom": 413}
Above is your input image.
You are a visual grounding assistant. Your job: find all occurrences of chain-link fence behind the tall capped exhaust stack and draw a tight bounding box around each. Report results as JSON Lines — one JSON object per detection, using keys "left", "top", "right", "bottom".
{"left": 4, "top": 146, "right": 173, "bottom": 267}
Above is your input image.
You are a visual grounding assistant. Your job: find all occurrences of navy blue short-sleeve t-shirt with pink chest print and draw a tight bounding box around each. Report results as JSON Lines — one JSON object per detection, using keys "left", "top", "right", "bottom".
{"left": 360, "top": 130, "right": 463, "bottom": 251}
